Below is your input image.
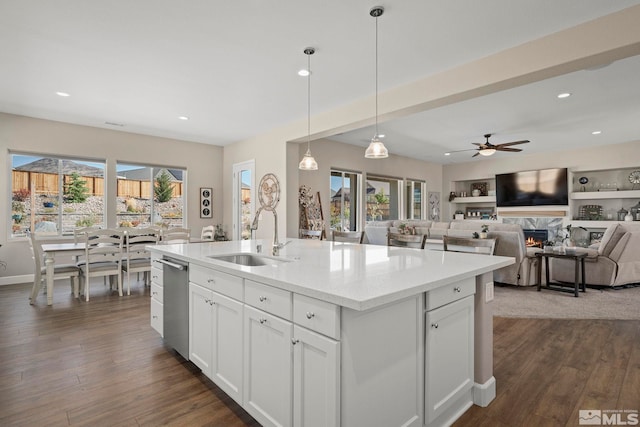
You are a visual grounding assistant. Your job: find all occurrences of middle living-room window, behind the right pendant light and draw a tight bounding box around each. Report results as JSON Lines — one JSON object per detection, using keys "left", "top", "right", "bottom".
{"left": 366, "top": 175, "right": 401, "bottom": 221}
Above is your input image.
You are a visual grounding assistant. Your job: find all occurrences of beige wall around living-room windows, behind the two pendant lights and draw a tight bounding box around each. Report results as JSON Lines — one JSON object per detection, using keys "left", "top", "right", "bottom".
{"left": 287, "top": 139, "right": 442, "bottom": 237}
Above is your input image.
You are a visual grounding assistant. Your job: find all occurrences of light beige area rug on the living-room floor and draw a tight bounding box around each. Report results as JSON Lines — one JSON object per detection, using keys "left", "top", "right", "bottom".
{"left": 493, "top": 285, "right": 640, "bottom": 320}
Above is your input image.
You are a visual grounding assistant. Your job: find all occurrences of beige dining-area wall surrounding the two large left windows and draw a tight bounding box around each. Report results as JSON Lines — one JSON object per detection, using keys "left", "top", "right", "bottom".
{"left": 0, "top": 113, "right": 223, "bottom": 283}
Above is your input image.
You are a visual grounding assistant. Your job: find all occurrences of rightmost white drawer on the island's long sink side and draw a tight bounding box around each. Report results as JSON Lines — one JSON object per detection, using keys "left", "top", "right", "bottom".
{"left": 293, "top": 294, "right": 340, "bottom": 340}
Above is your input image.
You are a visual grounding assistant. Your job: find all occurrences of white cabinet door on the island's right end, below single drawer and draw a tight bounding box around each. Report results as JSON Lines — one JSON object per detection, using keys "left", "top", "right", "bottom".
{"left": 425, "top": 296, "right": 473, "bottom": 424}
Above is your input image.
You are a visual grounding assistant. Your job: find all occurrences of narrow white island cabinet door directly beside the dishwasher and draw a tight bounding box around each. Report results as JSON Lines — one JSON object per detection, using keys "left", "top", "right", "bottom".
{"left": 189, "top": 283, "right": 213, "bottom": 378}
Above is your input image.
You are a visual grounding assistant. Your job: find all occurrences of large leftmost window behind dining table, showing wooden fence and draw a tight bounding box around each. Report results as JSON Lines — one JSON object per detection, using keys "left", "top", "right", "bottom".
{"left": 9, "top": 153, "right": 105, "bottom": 237}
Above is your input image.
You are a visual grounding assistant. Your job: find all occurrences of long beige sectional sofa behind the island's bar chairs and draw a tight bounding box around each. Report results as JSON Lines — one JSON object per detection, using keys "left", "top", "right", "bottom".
{"left": 365, "top": 220, "right": 537, "bottom": 286}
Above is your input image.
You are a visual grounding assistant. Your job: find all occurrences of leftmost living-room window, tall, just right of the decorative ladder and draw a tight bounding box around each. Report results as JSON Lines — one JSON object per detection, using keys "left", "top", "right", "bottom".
{"left": 329, "top": 170, "right": 362, "bottom": 231}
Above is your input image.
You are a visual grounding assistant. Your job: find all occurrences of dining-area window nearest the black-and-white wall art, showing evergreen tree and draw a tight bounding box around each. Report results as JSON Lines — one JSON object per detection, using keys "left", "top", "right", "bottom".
{"left": 116, "top": 163, "right": 186, "bottom": 231}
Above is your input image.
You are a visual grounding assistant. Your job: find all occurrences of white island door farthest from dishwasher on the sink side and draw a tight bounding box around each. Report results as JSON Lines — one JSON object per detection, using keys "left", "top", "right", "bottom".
{"left": 293, "top": 325, "right": 340, "bottom": 427}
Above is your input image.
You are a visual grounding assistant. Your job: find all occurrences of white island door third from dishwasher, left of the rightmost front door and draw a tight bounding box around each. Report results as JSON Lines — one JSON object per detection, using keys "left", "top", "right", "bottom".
{"left": 243, "top": 305, "right": 293, "bottom": 427}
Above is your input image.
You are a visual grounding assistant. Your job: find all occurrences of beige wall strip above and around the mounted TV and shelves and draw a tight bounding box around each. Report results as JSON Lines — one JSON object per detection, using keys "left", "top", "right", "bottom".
{"left": 441, "top": 140, "right": 640, "bottom": 219}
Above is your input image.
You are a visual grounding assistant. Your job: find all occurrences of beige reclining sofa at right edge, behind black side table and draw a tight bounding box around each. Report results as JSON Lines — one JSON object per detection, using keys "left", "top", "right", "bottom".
{"left": 549, "top": 222, "right": 640, "bottom": 286}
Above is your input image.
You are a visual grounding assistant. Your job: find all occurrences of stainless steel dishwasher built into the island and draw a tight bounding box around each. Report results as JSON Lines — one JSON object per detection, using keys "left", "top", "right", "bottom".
{"left": 158, "top": 257, "right": 189, "bottom": 360}
